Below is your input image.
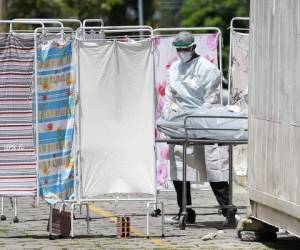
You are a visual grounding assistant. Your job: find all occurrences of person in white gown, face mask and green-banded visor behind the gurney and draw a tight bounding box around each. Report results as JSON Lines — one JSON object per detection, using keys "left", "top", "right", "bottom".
{"left": 162, "top": 31, "right": 237, "bottom": 225}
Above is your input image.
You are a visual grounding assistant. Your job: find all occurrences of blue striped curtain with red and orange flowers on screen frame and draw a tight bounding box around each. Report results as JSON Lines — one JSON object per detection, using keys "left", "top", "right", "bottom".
{"left": 33, "top": 40, "right": 75, "bottom": 203}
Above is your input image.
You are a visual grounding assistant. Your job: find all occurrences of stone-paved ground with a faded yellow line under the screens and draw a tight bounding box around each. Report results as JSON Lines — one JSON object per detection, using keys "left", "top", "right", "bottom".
{"left": 0, "top": 185, "right": 300, "bottom": 249}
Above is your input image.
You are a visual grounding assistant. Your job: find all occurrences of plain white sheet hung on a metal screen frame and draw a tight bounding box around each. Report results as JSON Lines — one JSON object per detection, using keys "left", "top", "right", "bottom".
{"left": 79, "top": 40, "right": 156, "bottom": 198}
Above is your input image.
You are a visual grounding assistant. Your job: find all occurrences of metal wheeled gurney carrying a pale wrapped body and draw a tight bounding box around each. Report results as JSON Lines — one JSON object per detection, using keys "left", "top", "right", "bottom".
{"left": 156, "top": 107, "right": 248, "bottom": 230}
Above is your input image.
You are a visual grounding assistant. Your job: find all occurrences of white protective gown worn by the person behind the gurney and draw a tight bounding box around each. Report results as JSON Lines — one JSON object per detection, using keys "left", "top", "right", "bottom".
{"left": 162, "top": 56, "right": 228, "bottom": 182}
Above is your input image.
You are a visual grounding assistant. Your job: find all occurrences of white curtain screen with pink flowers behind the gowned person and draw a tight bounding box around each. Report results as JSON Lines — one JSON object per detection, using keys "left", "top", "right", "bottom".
{"left": 154, "top": 28, "right": 222, "bottom": 189}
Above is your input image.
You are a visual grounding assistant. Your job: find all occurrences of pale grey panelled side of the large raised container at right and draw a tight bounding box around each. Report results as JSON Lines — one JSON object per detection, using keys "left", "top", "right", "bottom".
{"left": 248, "top": 0, "right": 300, "bottom": 236}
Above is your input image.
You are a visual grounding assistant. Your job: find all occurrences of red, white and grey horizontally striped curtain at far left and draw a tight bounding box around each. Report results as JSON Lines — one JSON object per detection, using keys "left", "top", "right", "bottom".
{"left": 0, "top": 34, "right": 36, "bottom": 196}
